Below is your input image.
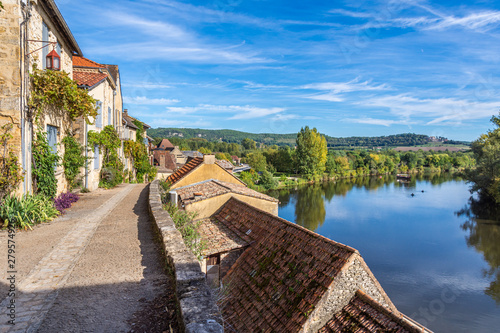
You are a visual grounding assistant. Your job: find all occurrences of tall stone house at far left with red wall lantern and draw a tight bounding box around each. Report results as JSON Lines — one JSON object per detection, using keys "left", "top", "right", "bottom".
{"left": 0, "top": 0, "right": 82, "bottom": 194}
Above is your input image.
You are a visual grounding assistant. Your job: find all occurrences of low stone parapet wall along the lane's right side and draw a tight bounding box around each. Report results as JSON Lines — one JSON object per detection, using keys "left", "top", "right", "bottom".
{"left": 149, "top": 180, "right": 224, "bottom": 333}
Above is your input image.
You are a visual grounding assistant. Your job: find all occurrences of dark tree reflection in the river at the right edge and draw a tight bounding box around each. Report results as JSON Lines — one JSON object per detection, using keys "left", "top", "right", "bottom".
{"left": 456, "top": 198, "right": 500, "bottom": 304}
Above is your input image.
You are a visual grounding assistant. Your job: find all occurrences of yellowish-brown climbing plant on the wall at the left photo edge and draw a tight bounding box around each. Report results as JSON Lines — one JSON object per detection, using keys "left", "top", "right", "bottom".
{"left": 0, "top": 124, "right": 23, "bottom": 202}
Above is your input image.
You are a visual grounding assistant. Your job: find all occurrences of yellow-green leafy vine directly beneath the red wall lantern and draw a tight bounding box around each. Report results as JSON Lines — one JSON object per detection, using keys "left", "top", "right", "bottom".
{"left": 28, "top": 65, "right": 97, "bottom": 124}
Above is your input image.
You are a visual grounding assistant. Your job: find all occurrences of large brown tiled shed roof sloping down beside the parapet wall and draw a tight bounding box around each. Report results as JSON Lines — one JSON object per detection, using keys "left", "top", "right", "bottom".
{"left": 217, "top": 198, "right": 356, "bottom": 332}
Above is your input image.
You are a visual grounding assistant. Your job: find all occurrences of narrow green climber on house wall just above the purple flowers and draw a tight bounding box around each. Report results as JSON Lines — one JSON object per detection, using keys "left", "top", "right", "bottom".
{"left": 62, "top": 133, "right": 87, "bottom": 188}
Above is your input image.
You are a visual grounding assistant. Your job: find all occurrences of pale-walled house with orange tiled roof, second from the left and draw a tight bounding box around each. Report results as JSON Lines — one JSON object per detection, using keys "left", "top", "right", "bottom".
{"left": 73, "top": 56, "right": 123, "bottom": 191}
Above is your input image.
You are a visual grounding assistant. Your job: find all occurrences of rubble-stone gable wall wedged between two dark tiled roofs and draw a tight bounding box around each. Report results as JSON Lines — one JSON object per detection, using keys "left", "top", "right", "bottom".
{"left": 302, "top": 253, "right": 399, "bottom": 333}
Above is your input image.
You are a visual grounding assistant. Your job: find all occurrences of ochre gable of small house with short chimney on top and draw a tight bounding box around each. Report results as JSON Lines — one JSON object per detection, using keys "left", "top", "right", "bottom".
{"left": 167, "top": 155, "right": 246, "bottom": 190}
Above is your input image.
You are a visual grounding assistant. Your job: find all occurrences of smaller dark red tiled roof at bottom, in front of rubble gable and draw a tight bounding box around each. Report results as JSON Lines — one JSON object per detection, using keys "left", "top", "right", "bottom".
{"left": 318, "top": 290, "right": 422, "bottom": 333}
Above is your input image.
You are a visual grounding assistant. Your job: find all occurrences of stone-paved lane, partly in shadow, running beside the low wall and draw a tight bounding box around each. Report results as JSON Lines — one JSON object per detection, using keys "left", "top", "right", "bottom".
{"left": 0, "top": 185, "right": 178, "bottom": 333}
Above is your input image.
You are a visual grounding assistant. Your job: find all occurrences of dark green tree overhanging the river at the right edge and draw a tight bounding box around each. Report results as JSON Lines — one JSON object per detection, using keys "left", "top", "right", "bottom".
{"left": 466, "top": 116, "right": 500, "bottom": 204}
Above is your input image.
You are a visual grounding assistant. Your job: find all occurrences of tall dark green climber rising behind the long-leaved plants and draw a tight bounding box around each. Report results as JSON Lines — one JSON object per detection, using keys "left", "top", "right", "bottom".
{"left": 33, "top": 131, "right": 59, "bottom": 198}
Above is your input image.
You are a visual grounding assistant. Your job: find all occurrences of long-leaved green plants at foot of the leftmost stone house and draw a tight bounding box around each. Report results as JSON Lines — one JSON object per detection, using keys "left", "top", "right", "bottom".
{"left": 0, "top": 194, "right": 59, "bottom": 230}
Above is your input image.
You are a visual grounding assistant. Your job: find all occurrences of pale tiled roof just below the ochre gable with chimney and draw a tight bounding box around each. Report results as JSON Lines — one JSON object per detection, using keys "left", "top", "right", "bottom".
{"left": 175, "top": 179, "right": 278, "bottom": 205}
